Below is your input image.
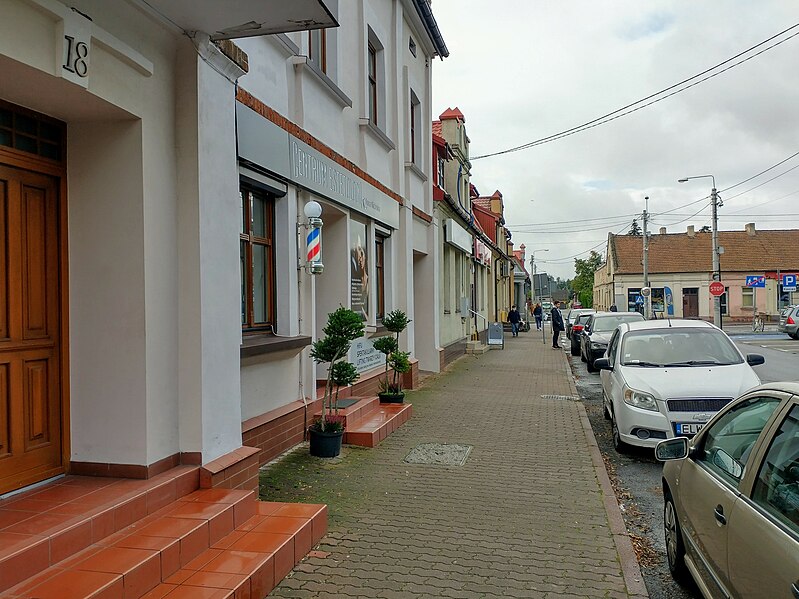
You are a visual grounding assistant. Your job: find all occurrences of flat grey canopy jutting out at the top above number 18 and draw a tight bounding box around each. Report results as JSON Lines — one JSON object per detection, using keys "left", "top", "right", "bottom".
{"left": 140, "top": 0, "right": 338, "bottom": 39}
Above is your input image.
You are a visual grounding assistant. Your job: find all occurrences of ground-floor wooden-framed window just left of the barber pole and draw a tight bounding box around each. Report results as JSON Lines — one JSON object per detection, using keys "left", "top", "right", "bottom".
{"left": 239, "top": 186, "right": 277, "bottom": 332}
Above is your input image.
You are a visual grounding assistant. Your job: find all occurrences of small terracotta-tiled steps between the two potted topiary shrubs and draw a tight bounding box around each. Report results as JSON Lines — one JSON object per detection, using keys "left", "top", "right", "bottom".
{"left": 317, "top": 397, "right": 413, "bottom": 447}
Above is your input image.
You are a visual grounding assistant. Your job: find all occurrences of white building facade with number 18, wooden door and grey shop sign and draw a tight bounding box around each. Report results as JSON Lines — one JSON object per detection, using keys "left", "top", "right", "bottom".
{"left": 0, "top": 0, "right": 446, "bottom": 495}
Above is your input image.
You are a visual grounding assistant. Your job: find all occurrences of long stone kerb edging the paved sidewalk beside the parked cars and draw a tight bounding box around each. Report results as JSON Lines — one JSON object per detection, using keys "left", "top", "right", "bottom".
{"left": 563, "top": 354, "right": 649, "bottom": 599}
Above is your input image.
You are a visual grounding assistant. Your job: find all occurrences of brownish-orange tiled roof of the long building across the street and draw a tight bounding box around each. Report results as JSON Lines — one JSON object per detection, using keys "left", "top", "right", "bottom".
{"left": 608, "top": 229, "right": 799, "bottom": 274}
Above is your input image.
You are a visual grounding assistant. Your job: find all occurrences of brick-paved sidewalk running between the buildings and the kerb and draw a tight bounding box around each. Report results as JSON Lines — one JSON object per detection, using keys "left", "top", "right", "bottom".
{"left": 262, "top": 331, "right": 646, "bottom": 598}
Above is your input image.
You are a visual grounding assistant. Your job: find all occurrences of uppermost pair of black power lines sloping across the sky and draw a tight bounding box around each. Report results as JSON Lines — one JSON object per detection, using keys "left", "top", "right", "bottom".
{"left": 470, "top": 23, "right": 799, "bottom": 161}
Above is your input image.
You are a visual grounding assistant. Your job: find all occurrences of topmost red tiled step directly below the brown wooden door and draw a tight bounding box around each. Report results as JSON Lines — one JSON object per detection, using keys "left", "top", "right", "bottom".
{"left": 0, "top": 466, "right": 199, "bottom": 593}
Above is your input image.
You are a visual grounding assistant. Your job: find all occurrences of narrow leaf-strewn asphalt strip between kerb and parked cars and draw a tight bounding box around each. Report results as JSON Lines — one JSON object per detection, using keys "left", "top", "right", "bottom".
{"left": 562, "top": 339, "right": 700, "bottom": 599}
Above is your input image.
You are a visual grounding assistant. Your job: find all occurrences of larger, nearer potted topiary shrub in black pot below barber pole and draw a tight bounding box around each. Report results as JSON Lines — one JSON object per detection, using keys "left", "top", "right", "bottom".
{"left": 308, "top": 306, "right": 363, "bottom": 458}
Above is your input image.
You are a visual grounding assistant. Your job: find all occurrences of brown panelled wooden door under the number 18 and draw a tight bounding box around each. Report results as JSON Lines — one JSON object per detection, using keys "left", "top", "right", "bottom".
{"left": 0, "top": 164, "right": 65, "bottom": 494}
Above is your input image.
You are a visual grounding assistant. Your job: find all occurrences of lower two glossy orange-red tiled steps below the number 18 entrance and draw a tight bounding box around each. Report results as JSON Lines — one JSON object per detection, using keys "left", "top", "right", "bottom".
{"left": 0, "top": 489, "right": 327, "bottom": 599}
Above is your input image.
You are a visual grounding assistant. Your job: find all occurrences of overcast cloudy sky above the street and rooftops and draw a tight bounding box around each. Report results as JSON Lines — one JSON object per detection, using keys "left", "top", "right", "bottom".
{"left": 432, "top": 0, "right": 799, "bottom": 278}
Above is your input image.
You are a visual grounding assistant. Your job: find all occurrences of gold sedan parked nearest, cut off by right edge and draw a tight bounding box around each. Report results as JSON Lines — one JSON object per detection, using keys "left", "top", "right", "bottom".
{"left": 655, "top": 383, "right": 799, "bottom": 599}
